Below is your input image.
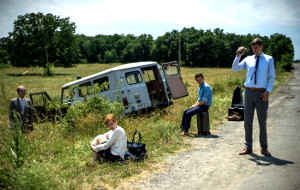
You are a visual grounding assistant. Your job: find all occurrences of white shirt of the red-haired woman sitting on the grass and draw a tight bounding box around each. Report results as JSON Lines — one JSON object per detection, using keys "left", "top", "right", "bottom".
{"left": 91, "top": 126, "right": 127, "bottom": 159}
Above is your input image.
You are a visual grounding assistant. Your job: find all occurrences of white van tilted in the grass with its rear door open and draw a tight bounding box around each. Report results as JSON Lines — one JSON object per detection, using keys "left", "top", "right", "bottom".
{"left": 61, "top": 61, "right": 188, "bottom": 114}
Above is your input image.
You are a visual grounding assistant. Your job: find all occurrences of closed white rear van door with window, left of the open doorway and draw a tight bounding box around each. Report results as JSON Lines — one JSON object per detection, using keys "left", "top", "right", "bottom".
{"left": 122, "top": 69, "right": 151, "bottom": 112}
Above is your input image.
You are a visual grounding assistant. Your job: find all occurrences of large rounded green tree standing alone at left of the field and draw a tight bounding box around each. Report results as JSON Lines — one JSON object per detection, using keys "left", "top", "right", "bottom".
{"left": 7, "top": 13, "right": 80, "bottom": 68}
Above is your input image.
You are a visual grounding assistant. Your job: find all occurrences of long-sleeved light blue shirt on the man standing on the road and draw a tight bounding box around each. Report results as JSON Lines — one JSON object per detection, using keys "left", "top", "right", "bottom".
{"left": 232, "top": 53, "right": 275, "bottom": 92}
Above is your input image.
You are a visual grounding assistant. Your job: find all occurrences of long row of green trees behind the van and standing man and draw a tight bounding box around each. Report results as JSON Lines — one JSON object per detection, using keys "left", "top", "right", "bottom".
{"left": 72, "top": 27, "right": 293, "bottom": 67}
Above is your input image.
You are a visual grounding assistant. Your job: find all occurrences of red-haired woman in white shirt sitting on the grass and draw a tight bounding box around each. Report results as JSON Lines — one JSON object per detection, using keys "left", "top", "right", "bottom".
{"left": 90, "top": 114, "right": 127, "bottom": 162}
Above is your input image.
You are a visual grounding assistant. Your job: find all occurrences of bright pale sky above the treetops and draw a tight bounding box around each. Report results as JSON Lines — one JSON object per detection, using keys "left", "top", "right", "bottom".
{"left": 0, "top": 0, "right": 300, "bottom": 59}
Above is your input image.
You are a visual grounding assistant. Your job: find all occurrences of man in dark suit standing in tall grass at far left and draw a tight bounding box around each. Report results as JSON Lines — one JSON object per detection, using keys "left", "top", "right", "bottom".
{"left": 9, "top": 86, "right": 33, "bottom": 133}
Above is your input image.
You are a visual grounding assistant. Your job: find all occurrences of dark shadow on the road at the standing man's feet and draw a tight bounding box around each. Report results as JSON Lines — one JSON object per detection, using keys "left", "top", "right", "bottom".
{"left": 249, "top": 153, "right": 295, "bottom": 166}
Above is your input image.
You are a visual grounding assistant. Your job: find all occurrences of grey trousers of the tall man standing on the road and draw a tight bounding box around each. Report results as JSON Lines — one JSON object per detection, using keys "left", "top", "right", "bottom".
{"left": 244, "top": 88, "right": 269, "bottom": 148}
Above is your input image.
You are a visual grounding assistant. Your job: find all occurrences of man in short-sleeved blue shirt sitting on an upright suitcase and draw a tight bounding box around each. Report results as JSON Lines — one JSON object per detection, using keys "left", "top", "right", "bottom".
{"left": 180, "top": 73, "right": 212, "bottom": 135}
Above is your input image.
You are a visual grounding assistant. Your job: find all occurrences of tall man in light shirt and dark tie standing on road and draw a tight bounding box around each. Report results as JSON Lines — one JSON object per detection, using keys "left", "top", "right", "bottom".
{"left": 232, "top": 38, "right": 275, "bottom": 156}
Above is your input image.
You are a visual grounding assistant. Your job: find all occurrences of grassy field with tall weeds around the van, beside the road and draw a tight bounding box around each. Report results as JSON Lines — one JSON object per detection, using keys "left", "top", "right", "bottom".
{"left": 0, "top": 64, "right": 289, "bottom": 189}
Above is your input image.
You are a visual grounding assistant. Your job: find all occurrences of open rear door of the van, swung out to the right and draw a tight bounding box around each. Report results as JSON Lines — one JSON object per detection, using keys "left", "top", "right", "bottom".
{"left": 162, "top": 61, "right": 189, "bottom": 99}
